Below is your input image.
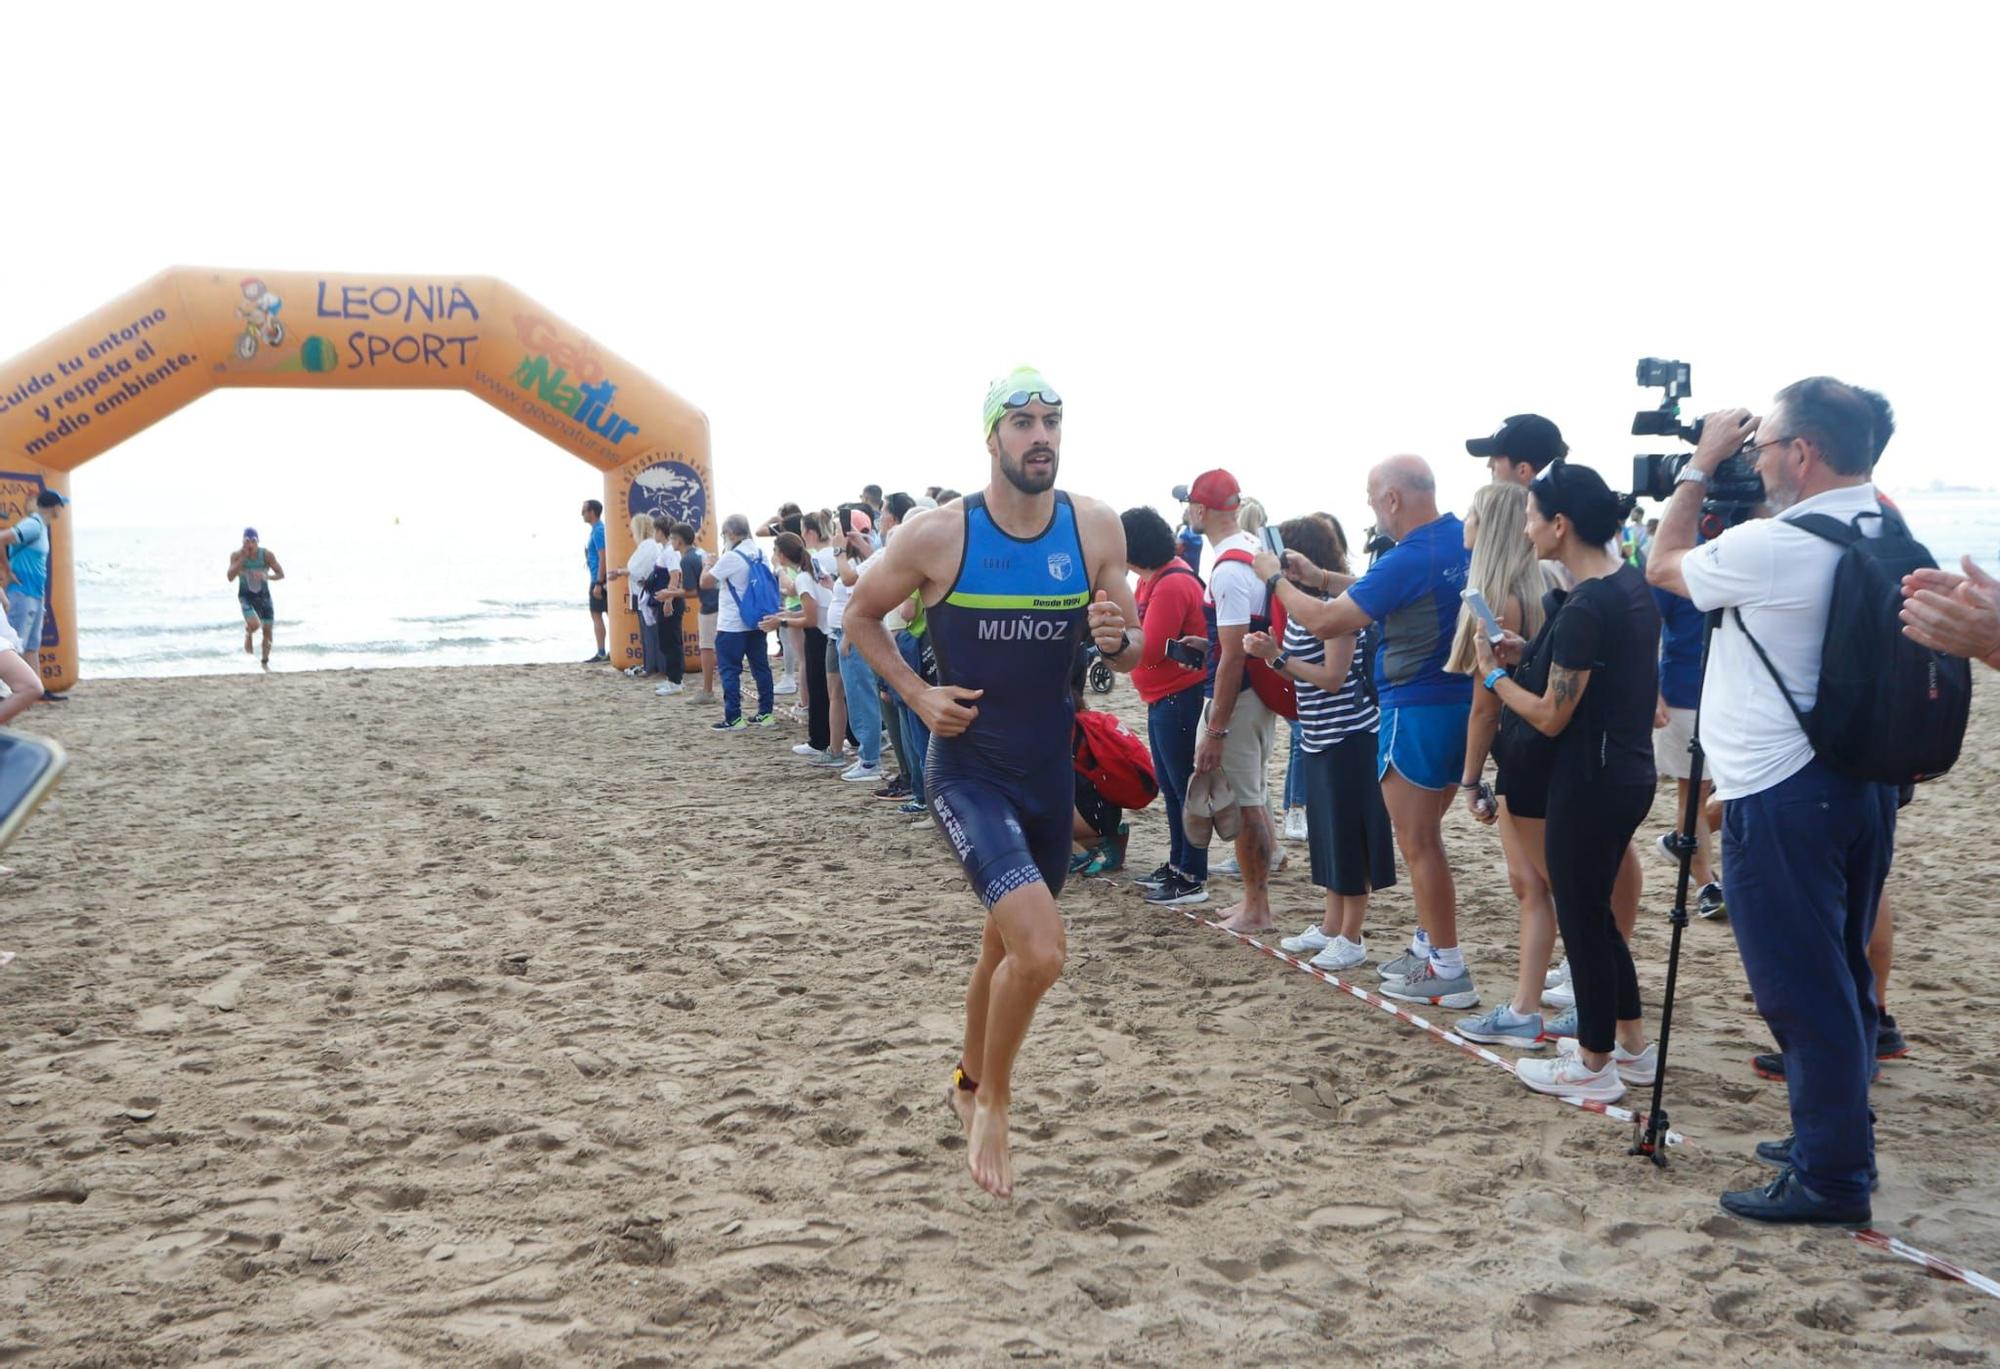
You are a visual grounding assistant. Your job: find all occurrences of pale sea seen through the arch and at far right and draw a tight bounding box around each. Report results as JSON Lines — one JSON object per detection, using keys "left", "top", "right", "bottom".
{"left": 56, "top": 492, "right": 2000, "bottom": 678}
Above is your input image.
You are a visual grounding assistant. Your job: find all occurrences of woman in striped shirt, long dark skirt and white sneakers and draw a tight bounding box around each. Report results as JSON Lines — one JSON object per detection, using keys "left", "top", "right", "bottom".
{"left": 1244, "top": 518, "right": 1396, "bottom": 971}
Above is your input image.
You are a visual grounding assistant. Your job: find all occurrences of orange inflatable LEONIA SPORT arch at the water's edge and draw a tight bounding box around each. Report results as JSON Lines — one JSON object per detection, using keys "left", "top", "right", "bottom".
{"left": 0, "top": 266, "right": 716, "bottom": 689}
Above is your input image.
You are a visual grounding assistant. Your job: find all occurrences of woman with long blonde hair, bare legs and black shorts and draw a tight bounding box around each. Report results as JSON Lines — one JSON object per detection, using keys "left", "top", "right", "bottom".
{"left": 1444, "top": 484, "right": 1556, "bottom": 1049}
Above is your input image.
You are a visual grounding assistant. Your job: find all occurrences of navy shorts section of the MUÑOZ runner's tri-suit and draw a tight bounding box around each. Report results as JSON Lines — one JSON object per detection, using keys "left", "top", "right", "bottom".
{"left": 924, "top": 737, "right": 1076, "bottom": 911}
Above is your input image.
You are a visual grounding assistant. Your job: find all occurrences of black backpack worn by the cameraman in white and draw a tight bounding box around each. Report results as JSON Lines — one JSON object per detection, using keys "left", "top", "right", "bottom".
{"left": 1732, "top": 508, "right": 1972, "bottom": 785}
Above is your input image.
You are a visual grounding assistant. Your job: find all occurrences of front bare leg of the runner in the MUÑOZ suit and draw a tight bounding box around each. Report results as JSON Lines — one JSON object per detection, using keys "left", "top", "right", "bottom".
{"left": 966, "top": 883, "right": 1068, "bottom": 1197}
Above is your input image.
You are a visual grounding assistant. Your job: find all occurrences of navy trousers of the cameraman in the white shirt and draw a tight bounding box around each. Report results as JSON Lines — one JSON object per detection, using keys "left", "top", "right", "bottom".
{"left": 1722, "top": 761, "right": 1896, "bottom": 1203}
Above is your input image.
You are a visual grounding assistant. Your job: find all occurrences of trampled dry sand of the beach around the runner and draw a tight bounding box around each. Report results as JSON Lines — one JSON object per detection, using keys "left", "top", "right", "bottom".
{"left": 0, "top": 666, "right": 2000, "bottom": 1365}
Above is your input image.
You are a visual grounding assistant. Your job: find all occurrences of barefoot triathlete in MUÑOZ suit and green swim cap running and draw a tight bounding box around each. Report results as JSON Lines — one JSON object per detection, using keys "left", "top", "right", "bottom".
{"left": 846, "top": 368, "right": 1140, "bottom": 1197}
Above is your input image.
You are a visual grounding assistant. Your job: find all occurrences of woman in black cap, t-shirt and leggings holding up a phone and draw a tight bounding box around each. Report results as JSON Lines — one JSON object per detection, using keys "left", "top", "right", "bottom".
{"left": 1472, "top": 460, "right": 1660, "bottom": 1103}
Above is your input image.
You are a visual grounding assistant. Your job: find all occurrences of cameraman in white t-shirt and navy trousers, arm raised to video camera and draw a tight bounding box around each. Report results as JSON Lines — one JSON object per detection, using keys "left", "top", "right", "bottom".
{"left": 1646, "top": 376, "right": 1896, "bottom": 1223}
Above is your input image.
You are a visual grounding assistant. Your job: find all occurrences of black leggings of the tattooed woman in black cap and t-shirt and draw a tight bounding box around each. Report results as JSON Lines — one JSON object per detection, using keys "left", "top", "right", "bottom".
{"left": 1542, "top": 783, "right": 1652, "bottom": 1051}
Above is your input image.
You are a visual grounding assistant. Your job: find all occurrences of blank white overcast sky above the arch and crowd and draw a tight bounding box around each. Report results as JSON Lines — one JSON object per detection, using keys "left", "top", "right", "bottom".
{"left": 0, "top": 2, "right": 2000, "bottom": 536}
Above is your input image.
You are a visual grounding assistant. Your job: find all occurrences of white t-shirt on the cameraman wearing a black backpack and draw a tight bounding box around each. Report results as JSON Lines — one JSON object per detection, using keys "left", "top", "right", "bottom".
{"left": 1680, "top": 484, "right": 1882, "bottom": 799}
